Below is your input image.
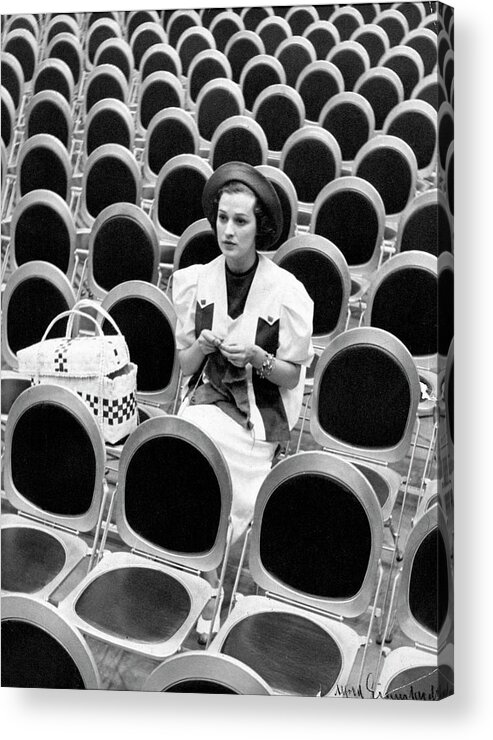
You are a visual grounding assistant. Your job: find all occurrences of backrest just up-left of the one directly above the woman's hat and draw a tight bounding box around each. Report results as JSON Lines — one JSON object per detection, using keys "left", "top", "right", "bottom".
{"left": 195, "top": 78, "right": 245, "bottom": 141}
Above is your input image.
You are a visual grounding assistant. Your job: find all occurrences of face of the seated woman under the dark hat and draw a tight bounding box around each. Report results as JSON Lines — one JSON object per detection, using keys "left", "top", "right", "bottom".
{"left": 216, "top": 193, "right": 257, "bottom": 272}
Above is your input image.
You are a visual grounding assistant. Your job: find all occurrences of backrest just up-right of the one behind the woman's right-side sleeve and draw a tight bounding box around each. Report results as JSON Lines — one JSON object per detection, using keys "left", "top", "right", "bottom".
{"left": 310, "top": 177, "right": 385, "bottom": 273}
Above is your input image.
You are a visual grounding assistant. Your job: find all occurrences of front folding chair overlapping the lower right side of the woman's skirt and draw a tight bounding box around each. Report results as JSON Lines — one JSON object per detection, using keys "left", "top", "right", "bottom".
{"left": 209, "top": 452, "right": 383, "bottom": 696}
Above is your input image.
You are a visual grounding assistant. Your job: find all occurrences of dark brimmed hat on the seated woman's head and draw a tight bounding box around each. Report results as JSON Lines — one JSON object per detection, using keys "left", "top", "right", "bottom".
{"left": 202, "top": 162, "right": 283, "bottom": 248}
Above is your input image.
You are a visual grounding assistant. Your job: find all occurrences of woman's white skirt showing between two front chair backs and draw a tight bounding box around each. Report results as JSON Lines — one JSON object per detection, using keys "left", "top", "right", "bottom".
{"left": 179, "top": 404, "right": 277, "bottom": 542}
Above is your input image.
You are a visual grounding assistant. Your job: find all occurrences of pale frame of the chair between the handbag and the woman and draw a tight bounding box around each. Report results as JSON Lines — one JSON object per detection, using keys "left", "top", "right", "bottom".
{"left": 101, "top": 280, "right": 180, "bottom": 407}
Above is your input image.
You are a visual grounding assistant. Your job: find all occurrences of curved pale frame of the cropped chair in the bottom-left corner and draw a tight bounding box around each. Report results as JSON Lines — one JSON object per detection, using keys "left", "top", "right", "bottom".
{"left": 2, "top": 595, "right": 102, "bottom": 689}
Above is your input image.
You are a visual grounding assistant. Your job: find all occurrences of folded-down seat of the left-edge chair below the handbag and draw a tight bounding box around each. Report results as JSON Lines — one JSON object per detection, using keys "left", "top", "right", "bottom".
{"left": 2, "top": 515, "right": 88, "bottom": 599}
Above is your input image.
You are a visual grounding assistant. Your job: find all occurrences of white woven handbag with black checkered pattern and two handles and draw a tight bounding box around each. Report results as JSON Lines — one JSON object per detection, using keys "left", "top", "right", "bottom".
{"left": 17, "top": 299, "right": 138, "bottom": 444}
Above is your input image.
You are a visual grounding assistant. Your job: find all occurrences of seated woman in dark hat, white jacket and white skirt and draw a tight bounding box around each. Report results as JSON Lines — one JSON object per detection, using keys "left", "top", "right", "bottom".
{"left": 173, "top": 162, "right": 313, "bottom": 636}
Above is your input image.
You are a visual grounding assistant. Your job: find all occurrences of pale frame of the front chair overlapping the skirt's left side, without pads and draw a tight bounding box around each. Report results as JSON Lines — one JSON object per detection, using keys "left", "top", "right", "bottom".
{"left": 58, "top": 416, "right": 232, "bottom": 660}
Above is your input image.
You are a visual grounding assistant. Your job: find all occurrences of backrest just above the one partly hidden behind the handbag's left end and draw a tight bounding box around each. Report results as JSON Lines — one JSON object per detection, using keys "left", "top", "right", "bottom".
{"left": 10, "top": 190, "right": 76, "bottom": 278}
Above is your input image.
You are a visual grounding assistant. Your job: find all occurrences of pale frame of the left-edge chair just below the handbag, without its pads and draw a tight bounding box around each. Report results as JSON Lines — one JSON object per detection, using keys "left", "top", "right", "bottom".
{"left": 2, "top": 384, "right": 108, "bottom": 600}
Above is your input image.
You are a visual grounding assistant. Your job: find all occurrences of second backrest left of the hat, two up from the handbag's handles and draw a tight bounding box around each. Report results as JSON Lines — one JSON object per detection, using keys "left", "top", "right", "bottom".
{"left": 80, "top": 144, "right": 141, "bottom": 225}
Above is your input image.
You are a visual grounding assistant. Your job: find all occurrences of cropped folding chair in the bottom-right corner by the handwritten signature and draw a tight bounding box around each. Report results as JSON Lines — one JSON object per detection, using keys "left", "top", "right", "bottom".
{"left": 375, "top": 505, "right": 454, "bottom": 701}
